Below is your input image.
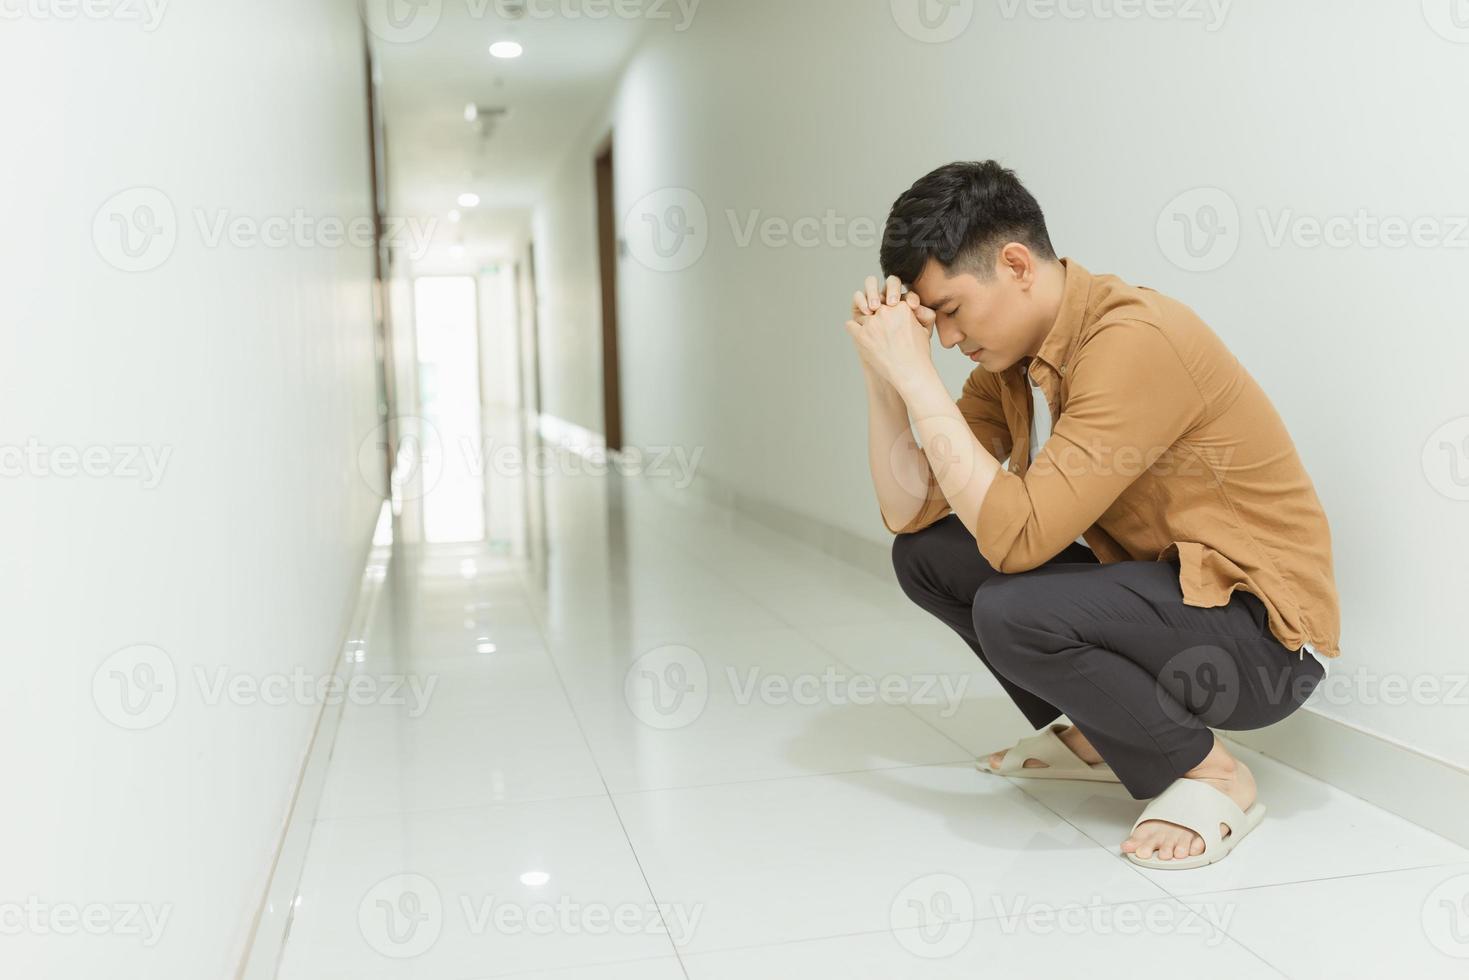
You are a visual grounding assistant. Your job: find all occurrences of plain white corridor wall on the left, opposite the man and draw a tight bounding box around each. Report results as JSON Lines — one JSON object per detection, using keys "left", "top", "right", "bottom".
{"left": 0, "top": 0, "right": 378, "bottom": 980}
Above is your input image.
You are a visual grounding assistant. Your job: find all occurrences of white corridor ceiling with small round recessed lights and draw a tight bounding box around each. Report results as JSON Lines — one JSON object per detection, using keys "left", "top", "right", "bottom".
{"left": 367, "top": 0, "right": 648, "bottom": 273}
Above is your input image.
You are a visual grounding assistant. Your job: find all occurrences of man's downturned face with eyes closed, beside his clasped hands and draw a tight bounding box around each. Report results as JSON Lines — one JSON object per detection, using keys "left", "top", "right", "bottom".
{"left": 912, "top": 256, "right": 1034, "bottom": 373}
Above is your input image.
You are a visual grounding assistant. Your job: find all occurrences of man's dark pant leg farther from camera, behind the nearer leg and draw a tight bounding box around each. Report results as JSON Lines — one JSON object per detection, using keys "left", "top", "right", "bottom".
{"left": 893, "top": 514, "right": 1097, "bottom": 729}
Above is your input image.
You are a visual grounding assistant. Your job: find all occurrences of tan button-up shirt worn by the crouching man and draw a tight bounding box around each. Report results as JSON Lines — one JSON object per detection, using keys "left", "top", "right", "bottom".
{"left": 883, "top": 259, "right": 1341, "bottom": 657}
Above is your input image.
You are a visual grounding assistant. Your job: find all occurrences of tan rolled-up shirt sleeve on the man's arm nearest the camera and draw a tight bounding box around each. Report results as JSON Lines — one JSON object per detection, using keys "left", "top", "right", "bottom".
{"left": 977, "top": 322, "right": 1205, "bottom": 573}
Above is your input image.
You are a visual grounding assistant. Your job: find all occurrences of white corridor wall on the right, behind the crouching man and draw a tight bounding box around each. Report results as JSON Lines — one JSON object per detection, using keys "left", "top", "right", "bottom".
{"left": 535, "top": 0, "right": 1469, "bottom": 765}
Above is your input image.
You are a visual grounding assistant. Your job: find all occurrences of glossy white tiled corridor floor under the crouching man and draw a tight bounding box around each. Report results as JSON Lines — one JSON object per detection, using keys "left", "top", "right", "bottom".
{"left": 279, "top": 464, "right": 1469, "bottom": 980}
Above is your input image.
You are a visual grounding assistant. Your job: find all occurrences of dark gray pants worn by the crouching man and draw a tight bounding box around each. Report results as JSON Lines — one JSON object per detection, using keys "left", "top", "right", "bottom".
{"left": 893, "top": 514, "right": 1324, "bottom": 799}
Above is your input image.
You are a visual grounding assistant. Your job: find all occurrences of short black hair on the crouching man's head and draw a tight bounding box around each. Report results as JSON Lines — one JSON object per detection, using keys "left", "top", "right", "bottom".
{"left": 881, "top": 160, "right": 1056, "bottom": 285}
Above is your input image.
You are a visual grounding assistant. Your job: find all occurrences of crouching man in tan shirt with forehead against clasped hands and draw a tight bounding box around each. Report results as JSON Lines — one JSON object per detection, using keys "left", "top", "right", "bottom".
{"left": 846, "top": 160, "right": 1340, "bottom": 868}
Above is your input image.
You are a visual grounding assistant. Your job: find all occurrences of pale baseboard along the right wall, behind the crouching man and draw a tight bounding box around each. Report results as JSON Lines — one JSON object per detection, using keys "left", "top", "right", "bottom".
{"left": 539, "top": 416, "right": 1469, "bottom": 846}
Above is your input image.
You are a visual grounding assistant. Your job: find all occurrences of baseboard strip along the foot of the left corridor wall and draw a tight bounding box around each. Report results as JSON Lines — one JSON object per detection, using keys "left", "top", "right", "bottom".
{"left": 235, "top": 501, "right": 392, "bottom": 980}
